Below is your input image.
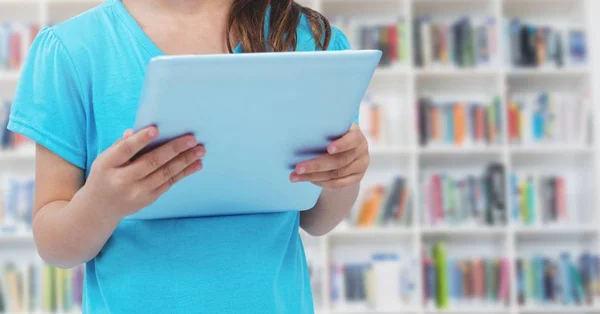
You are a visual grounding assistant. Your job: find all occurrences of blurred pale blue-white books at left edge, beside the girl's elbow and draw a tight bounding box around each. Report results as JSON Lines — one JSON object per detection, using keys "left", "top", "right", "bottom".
{"left": 0, "top": 175, "right": 34, "bottom": 233}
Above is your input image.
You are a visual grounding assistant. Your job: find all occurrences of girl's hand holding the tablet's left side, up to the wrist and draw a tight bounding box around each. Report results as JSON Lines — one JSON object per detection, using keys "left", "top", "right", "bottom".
{"left": 83, "top": 127, "right": 206, "bottom": 218}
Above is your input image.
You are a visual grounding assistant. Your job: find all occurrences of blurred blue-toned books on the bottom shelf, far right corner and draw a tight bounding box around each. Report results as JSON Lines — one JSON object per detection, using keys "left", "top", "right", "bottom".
{"left": 515, "top": 252, "right": 600, "bottom": 306}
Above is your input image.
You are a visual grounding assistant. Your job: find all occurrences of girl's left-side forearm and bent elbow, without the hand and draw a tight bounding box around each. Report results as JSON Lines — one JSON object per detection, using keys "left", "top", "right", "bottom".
{"left": 33, "top": 187, "right": 120, "bottom": 268}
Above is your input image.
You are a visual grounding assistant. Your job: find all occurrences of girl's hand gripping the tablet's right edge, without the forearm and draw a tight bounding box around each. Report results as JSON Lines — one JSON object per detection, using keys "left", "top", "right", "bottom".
{"left": 290, "top": 124, "right": 371, "bottom": 189}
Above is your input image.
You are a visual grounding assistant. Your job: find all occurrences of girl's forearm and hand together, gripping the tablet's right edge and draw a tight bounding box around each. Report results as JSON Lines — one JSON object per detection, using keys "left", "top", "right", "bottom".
{"left": 290, "top": 124, "right": 370, "bottom": 236}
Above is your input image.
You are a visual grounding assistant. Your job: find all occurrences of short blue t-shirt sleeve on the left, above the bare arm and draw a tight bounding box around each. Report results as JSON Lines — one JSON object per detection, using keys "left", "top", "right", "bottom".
{"left": 8, "top": 28, "right": 86, "bottom": 169}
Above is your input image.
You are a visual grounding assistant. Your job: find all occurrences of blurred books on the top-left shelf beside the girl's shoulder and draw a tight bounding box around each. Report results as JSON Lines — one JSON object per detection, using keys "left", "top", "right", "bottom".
{"left": 0, "top": 24, "right": 40, "bottom": 71}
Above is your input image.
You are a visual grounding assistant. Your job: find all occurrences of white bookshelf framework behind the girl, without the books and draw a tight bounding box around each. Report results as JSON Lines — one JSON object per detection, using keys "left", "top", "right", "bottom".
{"left": 0, "top": 0, "right": 600, "bottom": 314}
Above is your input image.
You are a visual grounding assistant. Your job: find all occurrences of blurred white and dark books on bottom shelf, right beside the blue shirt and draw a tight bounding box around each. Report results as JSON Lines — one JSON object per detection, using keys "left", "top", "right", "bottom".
{"left": 331, "top": 253, "right": 417, "bottom": 310}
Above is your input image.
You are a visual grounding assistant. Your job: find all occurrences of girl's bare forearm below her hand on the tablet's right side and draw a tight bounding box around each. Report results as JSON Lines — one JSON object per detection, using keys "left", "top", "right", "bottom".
{"left": 300, "top": 184, "right": 360, "bottom": 236}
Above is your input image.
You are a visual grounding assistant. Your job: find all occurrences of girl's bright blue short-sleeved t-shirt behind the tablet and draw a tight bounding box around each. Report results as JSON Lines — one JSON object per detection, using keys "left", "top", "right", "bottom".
{"left": 9, "top": 0, "right": 349, "bottom": 314}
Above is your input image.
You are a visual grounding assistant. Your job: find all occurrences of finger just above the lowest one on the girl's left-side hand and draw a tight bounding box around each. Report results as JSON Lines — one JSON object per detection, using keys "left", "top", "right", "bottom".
{"left": 127, "top": 135, "right": 206, "bottom": 180}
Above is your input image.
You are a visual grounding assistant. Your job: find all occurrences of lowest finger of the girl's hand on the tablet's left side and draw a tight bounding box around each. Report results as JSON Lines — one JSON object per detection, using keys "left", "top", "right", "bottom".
{"left": 143, "top": 146, "right": 204, "bottom": 189}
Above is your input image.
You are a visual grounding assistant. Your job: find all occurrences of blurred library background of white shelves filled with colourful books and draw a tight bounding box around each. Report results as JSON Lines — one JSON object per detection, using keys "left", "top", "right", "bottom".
{"left": 0, "top": 0, "right": 600, "bottom": 314}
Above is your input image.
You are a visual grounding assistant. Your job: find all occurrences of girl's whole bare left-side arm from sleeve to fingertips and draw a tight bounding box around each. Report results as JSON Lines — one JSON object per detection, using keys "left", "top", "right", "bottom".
{"left": 33, "top": 127, "right": 205, "bottom": 268}
